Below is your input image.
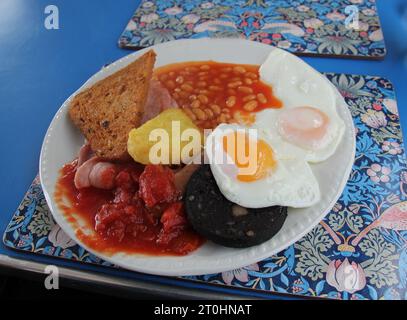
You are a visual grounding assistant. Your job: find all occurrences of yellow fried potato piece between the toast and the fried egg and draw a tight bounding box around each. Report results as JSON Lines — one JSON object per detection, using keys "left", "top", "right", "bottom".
{"left": 127, "top": 109, "right": 203, "bottom": 164}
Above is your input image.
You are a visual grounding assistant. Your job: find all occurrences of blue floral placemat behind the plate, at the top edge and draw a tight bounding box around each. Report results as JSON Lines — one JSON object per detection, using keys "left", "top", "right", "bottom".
{"left": 119, "top": 0, "right": 386, "bottom": 59}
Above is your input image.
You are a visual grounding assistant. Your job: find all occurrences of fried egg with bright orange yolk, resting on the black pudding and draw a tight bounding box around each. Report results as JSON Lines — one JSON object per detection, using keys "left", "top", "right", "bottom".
{"left": 205, "top": 124, "right": 320, "bottom": 208}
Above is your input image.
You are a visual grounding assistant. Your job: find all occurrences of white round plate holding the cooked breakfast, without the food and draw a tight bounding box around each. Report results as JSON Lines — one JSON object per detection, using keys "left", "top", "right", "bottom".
{"left": 40, "top": 39, "right": 355, "bottom": 276}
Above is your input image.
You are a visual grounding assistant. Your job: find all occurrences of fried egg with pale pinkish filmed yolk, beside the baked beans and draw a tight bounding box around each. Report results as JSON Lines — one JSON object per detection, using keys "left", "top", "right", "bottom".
{"left": 253, "top": 50, "right": 345, "bottom": 162}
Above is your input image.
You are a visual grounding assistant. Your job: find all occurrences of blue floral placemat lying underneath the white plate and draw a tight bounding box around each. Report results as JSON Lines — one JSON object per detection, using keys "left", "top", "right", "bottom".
{"left": 3, "top": 74, "right": 407, "bottom": 299}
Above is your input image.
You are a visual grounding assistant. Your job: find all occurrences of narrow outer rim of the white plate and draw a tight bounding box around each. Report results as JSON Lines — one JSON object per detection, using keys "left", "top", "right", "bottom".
{"left": 39, "top": 39, "right": 356, "bottom": 276}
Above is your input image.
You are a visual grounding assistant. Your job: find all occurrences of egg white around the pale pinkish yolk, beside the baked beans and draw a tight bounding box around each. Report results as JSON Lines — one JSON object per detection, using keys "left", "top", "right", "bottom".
{"left": 253, "top": 50, "right": 346, "bottom": 163}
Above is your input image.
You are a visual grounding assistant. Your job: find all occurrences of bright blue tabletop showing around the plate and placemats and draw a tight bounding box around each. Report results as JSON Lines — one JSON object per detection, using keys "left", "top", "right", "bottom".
{"left": 0, "top": 0, "right": 407, "bottom": 298}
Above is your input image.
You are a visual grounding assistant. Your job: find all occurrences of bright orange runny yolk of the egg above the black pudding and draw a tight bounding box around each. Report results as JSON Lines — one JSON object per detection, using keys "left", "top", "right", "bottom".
{"left": 223, "top": 132, "right": 276, "bottom": 182}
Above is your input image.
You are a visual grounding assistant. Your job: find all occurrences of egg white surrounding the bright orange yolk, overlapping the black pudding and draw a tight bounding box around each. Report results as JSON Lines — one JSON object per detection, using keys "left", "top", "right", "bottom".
{"left": 205, "top": 124, "right": 321, "bottom": 208}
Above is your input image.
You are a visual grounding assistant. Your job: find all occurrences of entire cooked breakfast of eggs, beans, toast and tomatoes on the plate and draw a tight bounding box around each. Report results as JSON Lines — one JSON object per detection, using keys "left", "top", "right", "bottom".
{"left": 55, "top": 49, "right": 344, "bottom": 255}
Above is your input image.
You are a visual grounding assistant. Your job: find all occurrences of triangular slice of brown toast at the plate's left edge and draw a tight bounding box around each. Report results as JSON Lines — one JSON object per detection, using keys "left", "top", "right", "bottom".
{"left": 69, "top": 50, "right": 156, "bottom": 160}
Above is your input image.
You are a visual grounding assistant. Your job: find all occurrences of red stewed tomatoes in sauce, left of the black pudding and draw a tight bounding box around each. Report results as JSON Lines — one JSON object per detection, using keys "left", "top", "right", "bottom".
{"left": 54, "top": 160, "right": 204, "bottom": 255}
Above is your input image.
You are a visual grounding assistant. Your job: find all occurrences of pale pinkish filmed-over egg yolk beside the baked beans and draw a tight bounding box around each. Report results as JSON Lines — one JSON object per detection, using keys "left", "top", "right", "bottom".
{"left": 278, "top": 107, "right": 329, "bottom": 150}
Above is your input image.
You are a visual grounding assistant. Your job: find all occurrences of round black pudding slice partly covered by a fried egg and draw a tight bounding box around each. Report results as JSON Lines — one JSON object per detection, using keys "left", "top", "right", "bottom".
{"left": 184, "top": 165, "right": 287, "bottom": 248}
